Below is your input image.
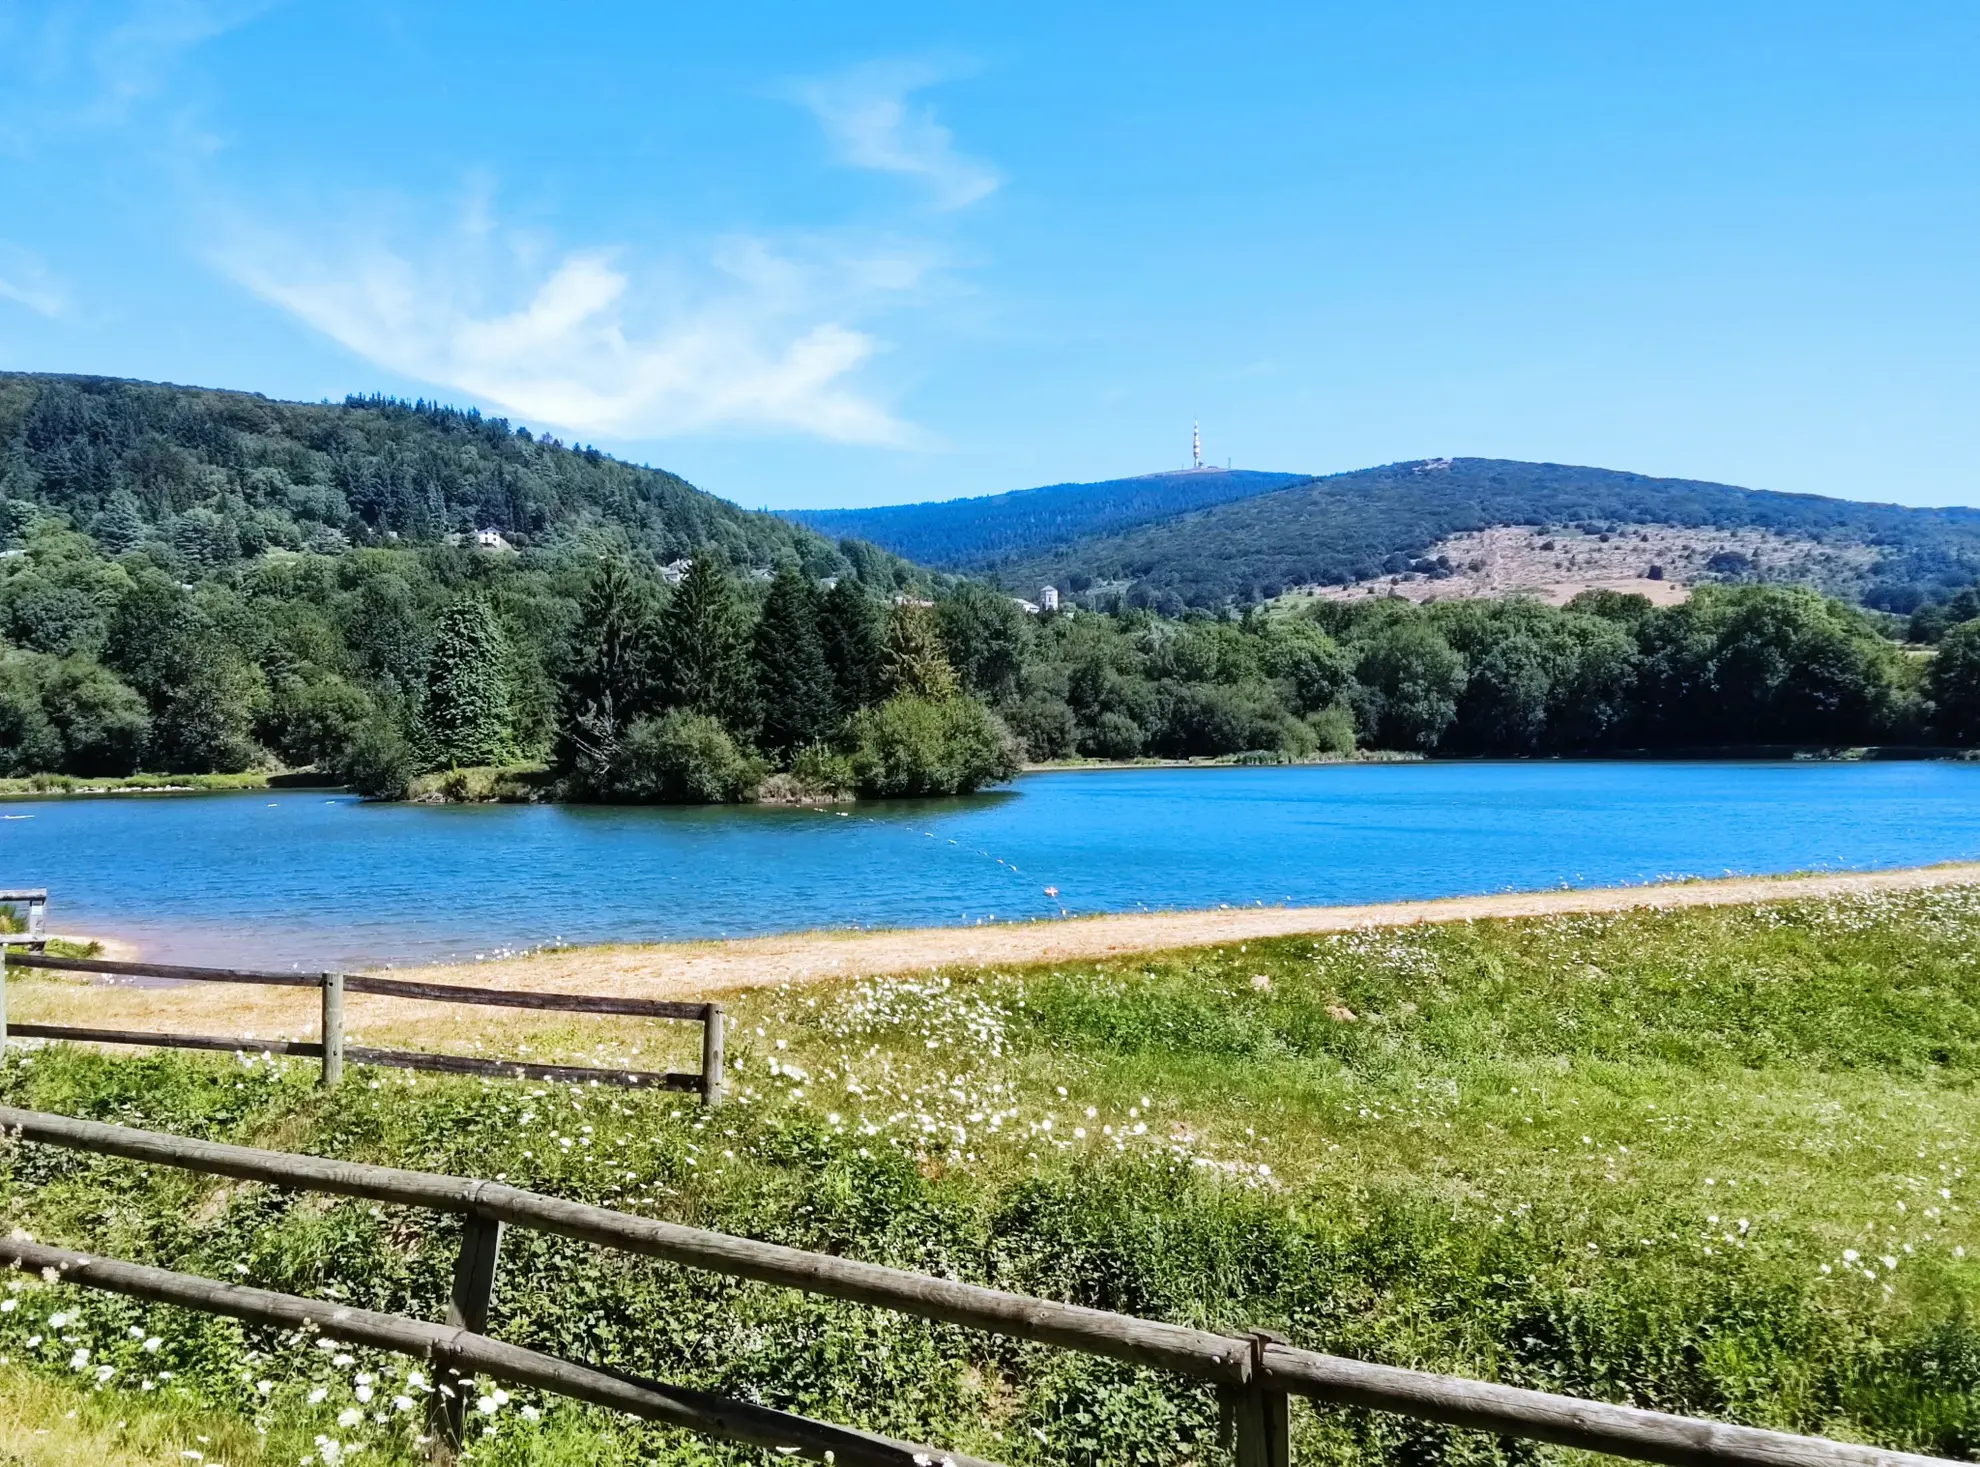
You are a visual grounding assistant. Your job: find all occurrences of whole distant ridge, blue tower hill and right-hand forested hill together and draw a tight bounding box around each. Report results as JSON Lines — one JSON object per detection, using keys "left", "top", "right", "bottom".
{"left": 806, "top": 457, "right": 1980, "bottom": 612}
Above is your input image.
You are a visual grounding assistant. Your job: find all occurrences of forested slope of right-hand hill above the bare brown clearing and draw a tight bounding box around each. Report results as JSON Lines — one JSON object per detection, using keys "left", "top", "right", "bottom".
{"left": 990, "top": 459, "right": 1980, "bottom": 612}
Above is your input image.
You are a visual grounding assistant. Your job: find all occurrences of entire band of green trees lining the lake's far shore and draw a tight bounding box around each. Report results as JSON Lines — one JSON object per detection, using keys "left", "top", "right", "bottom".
{"left": 0, "top": 496, "right": 1980, "bottom": 800}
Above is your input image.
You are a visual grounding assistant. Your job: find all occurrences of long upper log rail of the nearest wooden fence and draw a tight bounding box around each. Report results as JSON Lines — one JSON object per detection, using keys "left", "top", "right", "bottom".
{"left": 0, "top": 1107, "right": 1944, "bottom": 1467}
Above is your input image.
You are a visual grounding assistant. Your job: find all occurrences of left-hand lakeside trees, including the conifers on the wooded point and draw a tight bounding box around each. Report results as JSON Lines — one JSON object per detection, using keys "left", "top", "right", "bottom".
{"left": 0, "top": 517, "right": 1020, "bottom": 800}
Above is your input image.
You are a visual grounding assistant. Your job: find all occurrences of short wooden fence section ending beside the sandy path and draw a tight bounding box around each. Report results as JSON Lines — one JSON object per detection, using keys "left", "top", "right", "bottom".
{"left": 0, "top": 946, "right": 723, "bottom": 1105}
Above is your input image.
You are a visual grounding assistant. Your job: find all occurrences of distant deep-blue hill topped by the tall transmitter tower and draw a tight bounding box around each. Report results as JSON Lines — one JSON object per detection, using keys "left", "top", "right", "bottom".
{"left": 790, "top": 469, "right": 1307, "bottom": 570}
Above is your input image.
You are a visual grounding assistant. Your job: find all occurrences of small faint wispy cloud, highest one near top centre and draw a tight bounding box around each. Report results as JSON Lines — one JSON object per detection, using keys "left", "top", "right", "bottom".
{"left": 790, "top": 61, "right": 1004, "bottom": 208}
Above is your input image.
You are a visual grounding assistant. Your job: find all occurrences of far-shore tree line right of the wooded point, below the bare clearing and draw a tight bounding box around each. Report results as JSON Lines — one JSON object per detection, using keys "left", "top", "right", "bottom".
{"left": 970, "top": 586, "right": 1948, "bottom": 758}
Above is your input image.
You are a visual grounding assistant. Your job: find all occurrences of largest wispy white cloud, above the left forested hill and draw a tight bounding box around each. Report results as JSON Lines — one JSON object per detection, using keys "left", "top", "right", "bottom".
{"left": 216, "top": 204, "right": 929, "bottom": 445}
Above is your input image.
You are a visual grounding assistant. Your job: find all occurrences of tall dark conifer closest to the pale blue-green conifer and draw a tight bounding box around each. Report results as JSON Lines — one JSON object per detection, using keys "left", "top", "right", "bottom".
{"left": 558, "top": 554, "right": 657, "bottom": 772}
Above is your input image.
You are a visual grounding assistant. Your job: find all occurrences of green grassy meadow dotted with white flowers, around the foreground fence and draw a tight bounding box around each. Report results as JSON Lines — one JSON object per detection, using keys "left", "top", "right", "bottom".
{"left": 0, "top": 889, "right": 1980, "bottom": 1463}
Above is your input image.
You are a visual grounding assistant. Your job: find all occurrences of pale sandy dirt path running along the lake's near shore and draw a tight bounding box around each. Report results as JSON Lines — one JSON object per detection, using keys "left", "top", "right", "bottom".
{"left": 16, "top": 863, "right": 1980, "bottom": 1047}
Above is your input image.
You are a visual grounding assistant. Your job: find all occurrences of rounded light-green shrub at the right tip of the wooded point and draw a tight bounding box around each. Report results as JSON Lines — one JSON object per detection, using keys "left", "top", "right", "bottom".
{"left": 849, "top": 693, "right": 1022, "bottom": 798}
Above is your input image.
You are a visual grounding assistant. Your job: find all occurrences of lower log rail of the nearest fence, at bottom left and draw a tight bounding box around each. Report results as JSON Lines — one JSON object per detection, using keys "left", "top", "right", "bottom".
{"left": 0, "top": 1241, "right": 994, "bottom": 1467}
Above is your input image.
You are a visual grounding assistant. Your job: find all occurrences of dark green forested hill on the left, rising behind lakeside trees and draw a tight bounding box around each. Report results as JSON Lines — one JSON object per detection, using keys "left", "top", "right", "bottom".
{"left": 0, "top": 372, "right": 887, "bottom": 574}
